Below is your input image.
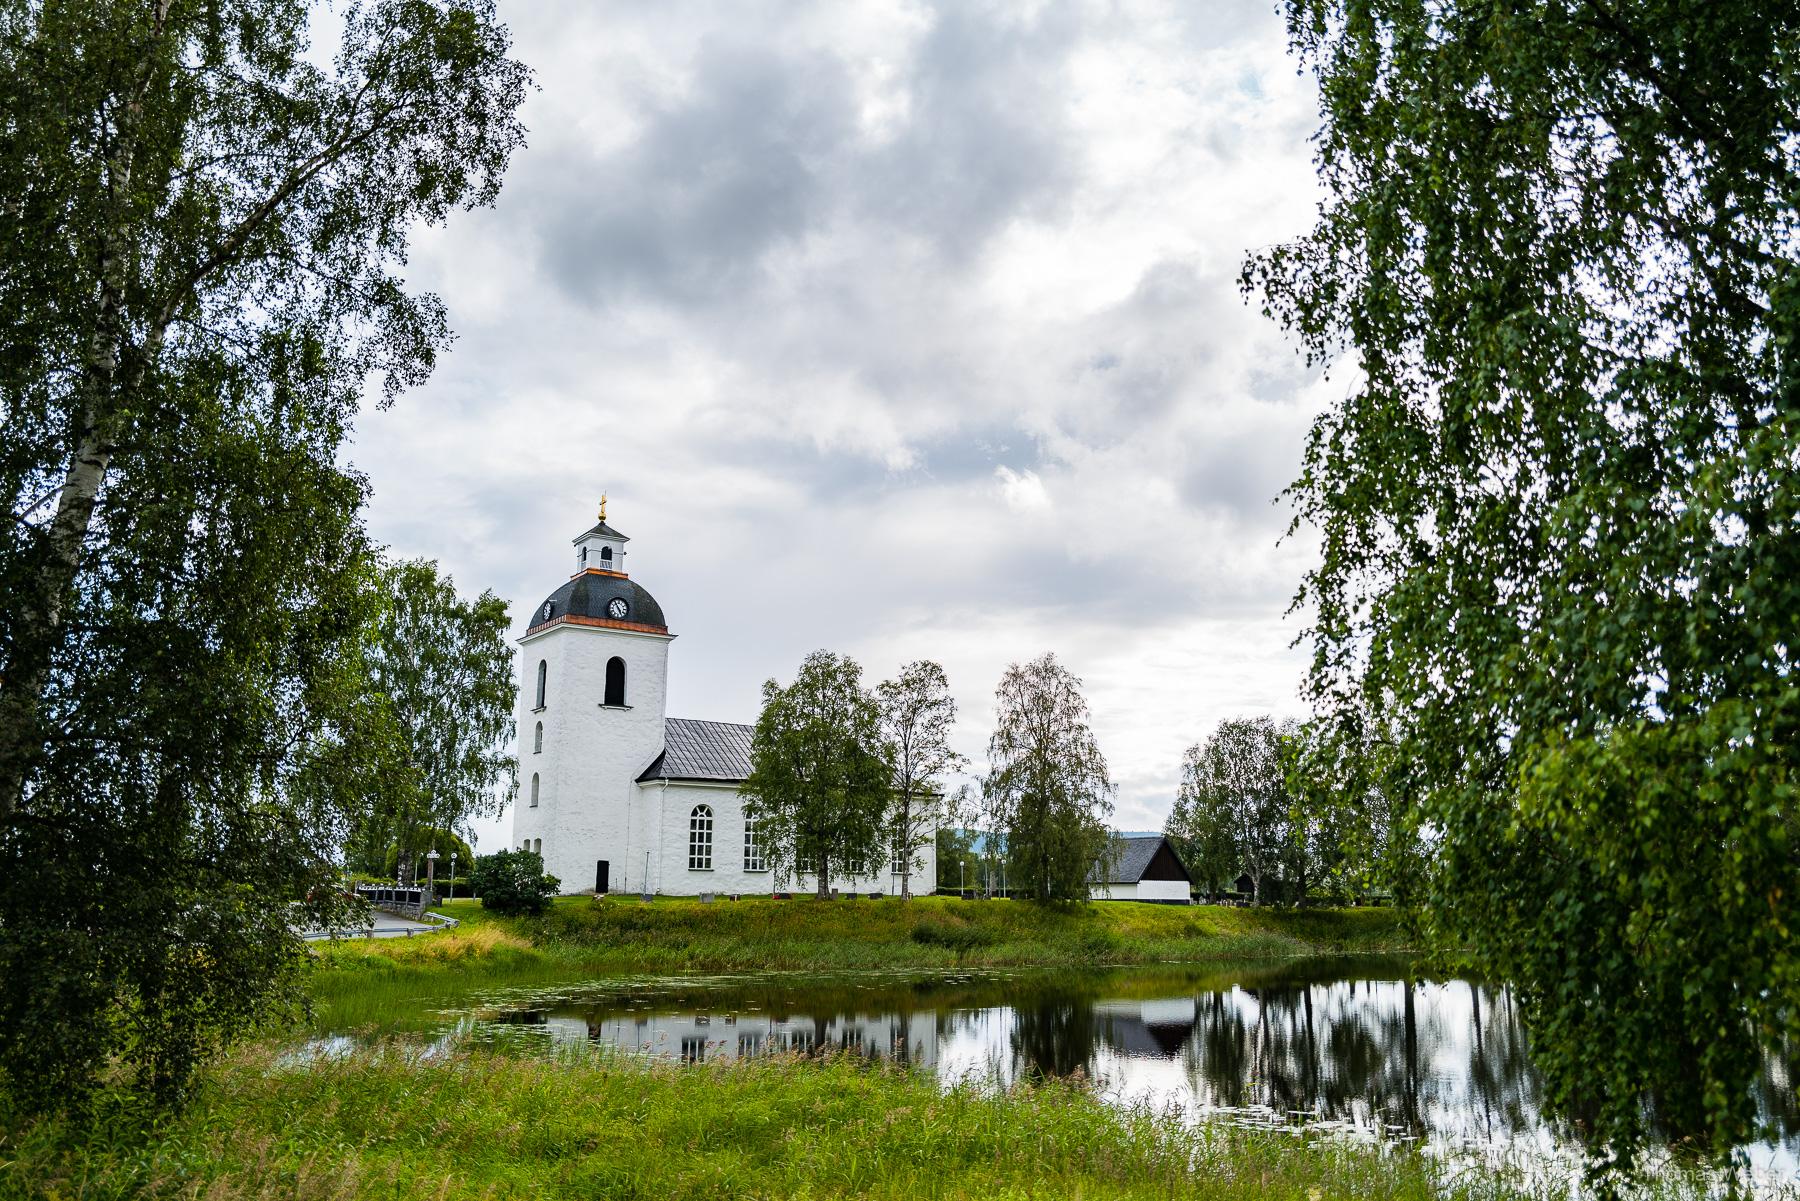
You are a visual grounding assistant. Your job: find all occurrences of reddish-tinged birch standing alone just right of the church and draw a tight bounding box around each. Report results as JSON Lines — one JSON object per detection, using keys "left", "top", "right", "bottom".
{"left": 983, "top": 654, "right": 1112, "bottom": 904}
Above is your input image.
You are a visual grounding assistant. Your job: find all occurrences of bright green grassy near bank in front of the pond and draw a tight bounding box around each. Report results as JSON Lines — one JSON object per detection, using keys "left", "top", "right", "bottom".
{"left": 0, "top": 1050, "right": 1656, "bottom": 1201}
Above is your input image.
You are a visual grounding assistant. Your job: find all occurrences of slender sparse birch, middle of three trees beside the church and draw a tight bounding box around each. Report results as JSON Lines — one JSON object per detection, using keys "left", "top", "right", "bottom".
{"left": 875, "top": 659, "right": 968, "bottom": 900}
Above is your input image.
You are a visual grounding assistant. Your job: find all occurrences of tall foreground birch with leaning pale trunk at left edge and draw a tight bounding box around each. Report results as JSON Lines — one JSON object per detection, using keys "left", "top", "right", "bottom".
{"left": 0, "top": 0, "right": 527, "bottom": 1107}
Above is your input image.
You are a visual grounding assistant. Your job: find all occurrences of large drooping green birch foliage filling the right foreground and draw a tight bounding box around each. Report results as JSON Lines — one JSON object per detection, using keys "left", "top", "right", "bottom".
{"left": 1246, "top": 0, "right": 1800, "bottom": 1156}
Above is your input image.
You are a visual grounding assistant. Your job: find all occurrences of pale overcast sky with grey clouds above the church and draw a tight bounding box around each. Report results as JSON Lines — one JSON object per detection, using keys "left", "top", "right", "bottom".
{"left": 351, "top": 0, "right": 1332, "bottom": 846}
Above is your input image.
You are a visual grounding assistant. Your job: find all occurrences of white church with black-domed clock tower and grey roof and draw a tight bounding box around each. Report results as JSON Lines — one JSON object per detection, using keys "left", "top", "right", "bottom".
{"left": 513, "top": 501, "right": 938, "bottom": 897}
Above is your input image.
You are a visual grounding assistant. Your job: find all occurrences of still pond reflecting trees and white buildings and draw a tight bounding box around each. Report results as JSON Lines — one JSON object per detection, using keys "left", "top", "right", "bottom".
{"left": 316, "top": 958, "right": 1800, "bottom": 1179}
